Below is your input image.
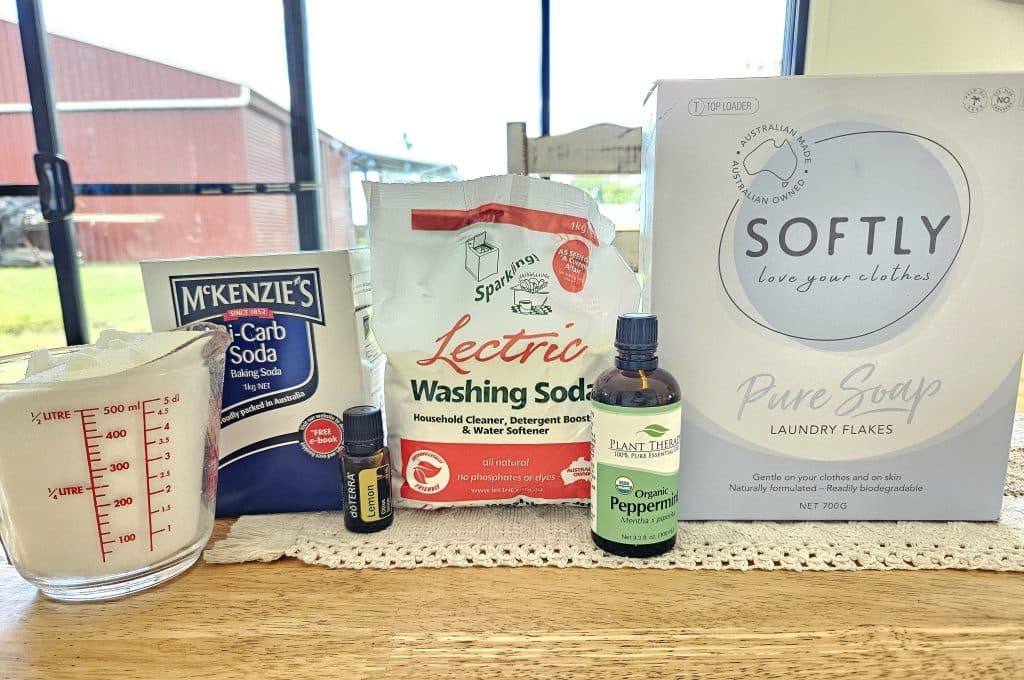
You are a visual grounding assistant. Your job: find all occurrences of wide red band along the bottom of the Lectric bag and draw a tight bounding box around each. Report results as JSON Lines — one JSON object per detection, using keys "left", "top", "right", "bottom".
{"left": 400, "top": 439, "right": 590, "bottom": 503}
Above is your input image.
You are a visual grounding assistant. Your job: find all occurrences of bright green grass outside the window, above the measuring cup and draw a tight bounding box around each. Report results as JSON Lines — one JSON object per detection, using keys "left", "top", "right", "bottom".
{"left": 0, "top": 264, "right": 150, "bottom": 354}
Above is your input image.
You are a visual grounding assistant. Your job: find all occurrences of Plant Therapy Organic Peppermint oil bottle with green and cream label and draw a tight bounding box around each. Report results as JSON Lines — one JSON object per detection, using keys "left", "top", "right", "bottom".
{"left": 590, "top": 314, "right": 682, "bottom": 557}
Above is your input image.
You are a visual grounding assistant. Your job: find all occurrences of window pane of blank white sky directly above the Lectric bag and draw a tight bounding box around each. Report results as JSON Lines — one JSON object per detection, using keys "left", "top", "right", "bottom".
{"left": 307, "top": 0, "right": 541, "bottom": 245}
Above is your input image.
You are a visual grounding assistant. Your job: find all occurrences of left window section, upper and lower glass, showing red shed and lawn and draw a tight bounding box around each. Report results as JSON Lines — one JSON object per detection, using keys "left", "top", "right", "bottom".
{"left": 0, "top": 0, "right": 296, "bottom": 351}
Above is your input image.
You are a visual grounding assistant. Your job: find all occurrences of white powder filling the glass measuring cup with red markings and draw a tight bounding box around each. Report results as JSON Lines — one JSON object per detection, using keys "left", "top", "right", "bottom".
{"left": 0, "top": 331, "right": 213, "bottom": 579}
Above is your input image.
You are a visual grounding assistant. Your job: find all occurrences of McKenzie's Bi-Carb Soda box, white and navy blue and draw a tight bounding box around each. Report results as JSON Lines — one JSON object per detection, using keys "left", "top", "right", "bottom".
{"left": 141, "top": 250, "right": 385, "bottom": 516}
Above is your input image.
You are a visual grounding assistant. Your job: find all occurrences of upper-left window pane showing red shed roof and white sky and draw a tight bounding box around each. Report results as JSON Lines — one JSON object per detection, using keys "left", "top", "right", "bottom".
{"left": 30, "top": 0, "right": 291, "bottom": 183}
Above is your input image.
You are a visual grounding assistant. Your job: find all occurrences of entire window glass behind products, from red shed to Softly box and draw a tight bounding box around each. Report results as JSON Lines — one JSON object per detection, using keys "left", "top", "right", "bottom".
{"left": 0, "top": 0, "right": 799, "bottom": 353}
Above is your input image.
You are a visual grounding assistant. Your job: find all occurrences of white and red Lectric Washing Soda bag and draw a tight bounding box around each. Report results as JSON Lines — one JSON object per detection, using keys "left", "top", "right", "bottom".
{"left": 365, "top": 176, "right": 640, "bottom": 508}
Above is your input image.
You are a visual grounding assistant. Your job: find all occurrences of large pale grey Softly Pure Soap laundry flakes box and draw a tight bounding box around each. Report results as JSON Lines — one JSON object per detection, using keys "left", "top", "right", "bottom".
{"left": 641, "top": 74, "right": 1024, "bottom": 520}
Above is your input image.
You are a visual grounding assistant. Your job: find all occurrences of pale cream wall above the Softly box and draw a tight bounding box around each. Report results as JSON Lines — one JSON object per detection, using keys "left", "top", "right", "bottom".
{"left": 805, "top": 0, "right": 1024, "bottom": 74}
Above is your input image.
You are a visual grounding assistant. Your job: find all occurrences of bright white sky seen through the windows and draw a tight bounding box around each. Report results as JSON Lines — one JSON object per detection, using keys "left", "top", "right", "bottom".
{"left": 0, "top": 0, "right": 785, "bottom": 177}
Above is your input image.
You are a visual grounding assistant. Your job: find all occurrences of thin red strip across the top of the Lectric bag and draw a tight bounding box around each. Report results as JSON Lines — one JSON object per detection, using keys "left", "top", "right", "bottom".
{"left": 412, "top": 203, "right": 600, "bottom": 246}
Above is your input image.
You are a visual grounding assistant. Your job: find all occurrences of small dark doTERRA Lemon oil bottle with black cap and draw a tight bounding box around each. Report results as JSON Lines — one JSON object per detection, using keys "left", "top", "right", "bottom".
{"left": 341, "top": 407, "right": 394, "bottom": 534}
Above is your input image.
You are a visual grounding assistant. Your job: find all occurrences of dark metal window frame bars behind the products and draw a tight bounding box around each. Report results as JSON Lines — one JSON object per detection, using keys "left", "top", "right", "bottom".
{"left": 0, "top": 0, "right": 811, "bottom": 345}
